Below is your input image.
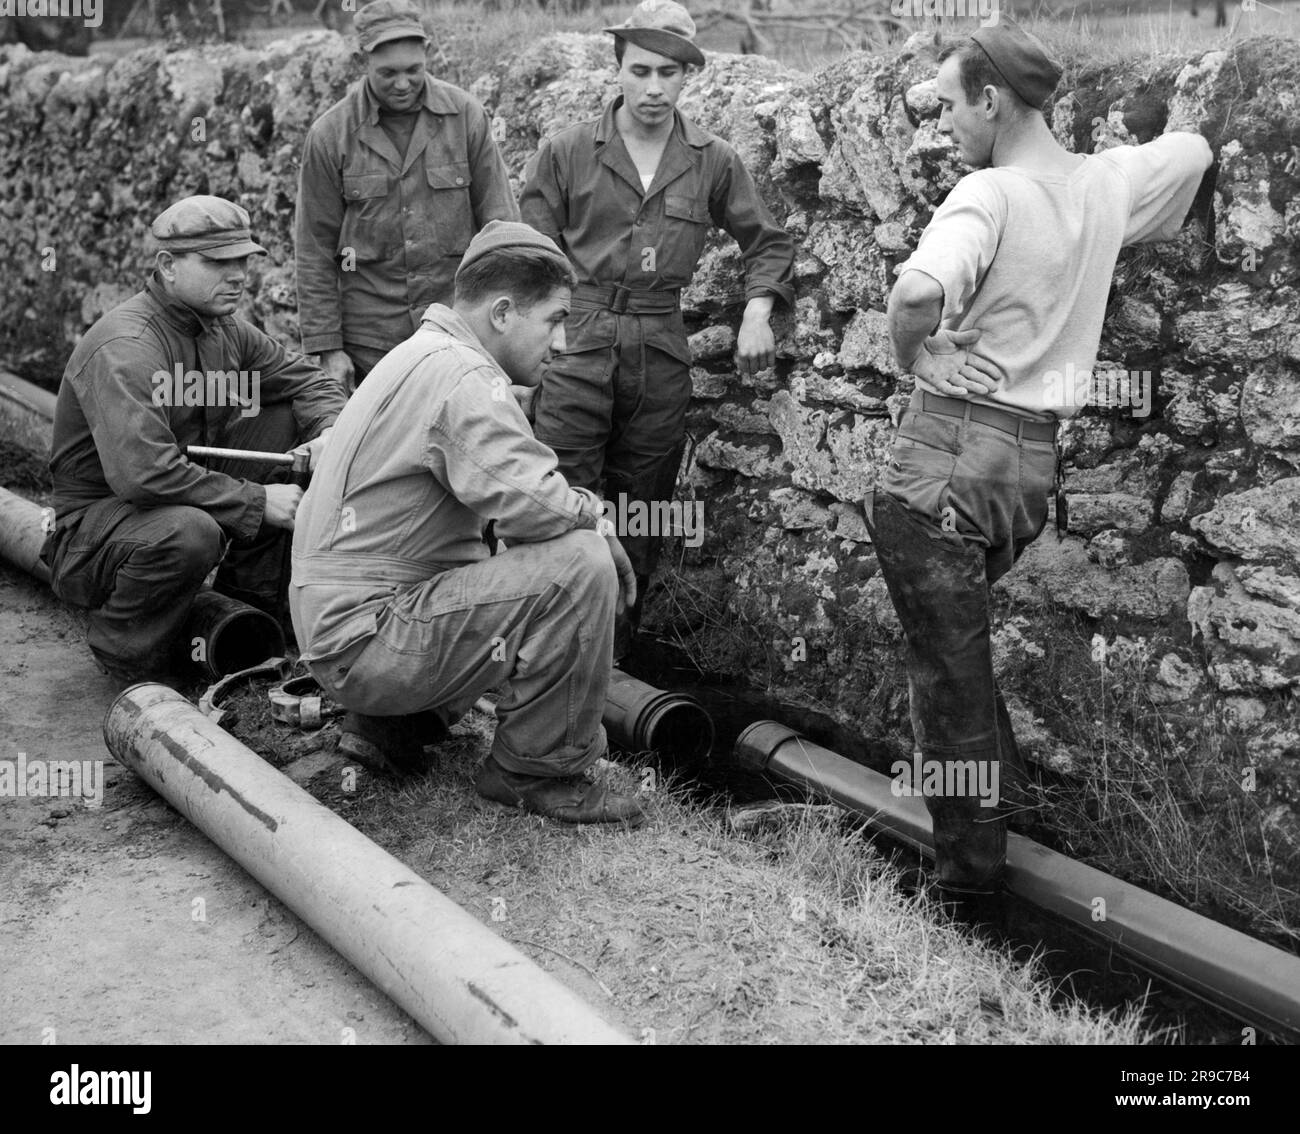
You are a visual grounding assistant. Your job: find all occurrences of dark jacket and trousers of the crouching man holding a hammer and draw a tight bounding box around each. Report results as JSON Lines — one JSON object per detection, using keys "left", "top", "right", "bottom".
{"left": 42, "top": 280, "right": 346, "bottom": 675}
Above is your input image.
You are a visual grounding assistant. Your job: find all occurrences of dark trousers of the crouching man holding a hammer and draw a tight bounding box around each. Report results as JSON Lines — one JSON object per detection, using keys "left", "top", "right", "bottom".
{"left": 42, "top": 402, "right": 296, "bottom": 678}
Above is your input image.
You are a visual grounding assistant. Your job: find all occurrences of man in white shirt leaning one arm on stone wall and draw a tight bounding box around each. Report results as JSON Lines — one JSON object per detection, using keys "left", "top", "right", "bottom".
{"left": 867, "top": 16, "right": 1212, "bottom": 923}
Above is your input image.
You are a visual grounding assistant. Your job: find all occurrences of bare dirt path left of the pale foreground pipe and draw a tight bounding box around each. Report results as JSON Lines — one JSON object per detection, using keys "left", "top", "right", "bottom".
{"left": 0, "top": 564, "right": 432, "bottom": 1044}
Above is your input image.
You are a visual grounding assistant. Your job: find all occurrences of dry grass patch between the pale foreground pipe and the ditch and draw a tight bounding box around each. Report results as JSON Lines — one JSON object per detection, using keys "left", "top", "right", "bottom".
{"left": 263, "top": 714, "right": 1156, "bottom": 1044}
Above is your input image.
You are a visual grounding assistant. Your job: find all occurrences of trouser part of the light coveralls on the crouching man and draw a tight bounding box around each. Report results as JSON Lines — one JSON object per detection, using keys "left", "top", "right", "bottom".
{"left": 309, "top": 531, "right": 618, "bottom": 776}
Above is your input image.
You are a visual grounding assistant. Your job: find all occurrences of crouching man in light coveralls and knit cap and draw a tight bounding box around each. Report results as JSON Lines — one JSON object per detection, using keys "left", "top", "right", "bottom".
{"left": 290, "top": 221, "right": 642, "bottom": 823}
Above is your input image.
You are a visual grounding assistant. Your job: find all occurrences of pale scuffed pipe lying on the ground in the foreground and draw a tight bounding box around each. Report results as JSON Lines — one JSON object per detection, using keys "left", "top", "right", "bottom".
{"left": 104, "top": 684, "right": 632, "bottom": 1044}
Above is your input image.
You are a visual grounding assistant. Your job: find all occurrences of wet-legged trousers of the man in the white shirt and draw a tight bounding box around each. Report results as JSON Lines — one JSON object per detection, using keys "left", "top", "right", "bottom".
{"left": 867, "top": 390, "right": 1057, "bottom": 892}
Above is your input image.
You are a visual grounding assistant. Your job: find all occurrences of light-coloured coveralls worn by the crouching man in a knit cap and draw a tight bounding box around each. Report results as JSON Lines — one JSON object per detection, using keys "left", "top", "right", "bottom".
{"left": 290, "top": 304, "right": 618, "bottom": 776}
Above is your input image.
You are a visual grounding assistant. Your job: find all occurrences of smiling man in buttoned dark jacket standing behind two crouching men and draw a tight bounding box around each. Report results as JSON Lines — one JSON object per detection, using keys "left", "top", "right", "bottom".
{"left": 294, "top": 0, "right": 519, "bottom": 390}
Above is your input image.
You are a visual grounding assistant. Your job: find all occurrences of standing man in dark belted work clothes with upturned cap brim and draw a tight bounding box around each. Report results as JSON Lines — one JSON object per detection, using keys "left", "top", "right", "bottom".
{"left": 520, "top": 0, "right": 794, "bottom": 657}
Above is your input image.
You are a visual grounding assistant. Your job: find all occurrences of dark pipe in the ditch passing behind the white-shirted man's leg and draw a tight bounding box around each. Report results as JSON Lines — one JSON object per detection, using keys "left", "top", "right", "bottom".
{"left": 735, "top": 720, "right": 1300, "bottom": 1033}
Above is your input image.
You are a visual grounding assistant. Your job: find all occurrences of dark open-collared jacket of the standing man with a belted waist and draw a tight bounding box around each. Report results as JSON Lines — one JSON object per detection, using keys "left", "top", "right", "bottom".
{"left": 520, "top": 96, "right": 794, "bottom": 360}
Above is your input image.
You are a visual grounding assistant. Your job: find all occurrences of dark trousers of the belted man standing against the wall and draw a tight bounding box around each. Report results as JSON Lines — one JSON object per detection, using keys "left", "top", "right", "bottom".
{"left": 533, "top": 307, "right": 690, "bottom": 580}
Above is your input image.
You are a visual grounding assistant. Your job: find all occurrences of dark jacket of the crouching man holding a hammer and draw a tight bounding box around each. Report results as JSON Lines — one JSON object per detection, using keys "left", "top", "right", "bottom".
{"left": 49, "top": 278, "right": 346, "bottom": 538}
